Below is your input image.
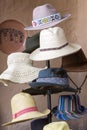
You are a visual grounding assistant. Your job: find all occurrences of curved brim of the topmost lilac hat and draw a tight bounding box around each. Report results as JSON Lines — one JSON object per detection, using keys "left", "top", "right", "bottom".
{"left": 24, "top": 14, "right": 71, "bottom": 30}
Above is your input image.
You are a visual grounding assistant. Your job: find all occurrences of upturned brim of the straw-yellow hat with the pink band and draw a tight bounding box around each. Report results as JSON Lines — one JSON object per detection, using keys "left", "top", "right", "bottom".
{"left": 2, "top": 109, "right": 50, "bottom": 126}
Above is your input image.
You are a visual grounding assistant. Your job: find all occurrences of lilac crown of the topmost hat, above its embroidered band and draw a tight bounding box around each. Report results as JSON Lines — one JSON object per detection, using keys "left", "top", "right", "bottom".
{"left": 33, "top": 4, "right": 57, "bottom": 20}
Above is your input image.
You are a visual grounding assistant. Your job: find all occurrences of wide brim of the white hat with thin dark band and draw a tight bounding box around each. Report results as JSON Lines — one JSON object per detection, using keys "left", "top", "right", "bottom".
{"left": 30, "top": 44, "right": 81, "bottom": 61}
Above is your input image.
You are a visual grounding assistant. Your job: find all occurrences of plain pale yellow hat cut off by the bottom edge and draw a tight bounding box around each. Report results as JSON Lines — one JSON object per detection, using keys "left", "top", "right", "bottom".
{"left": 43, "top": 121, "right": 70, "bottom": 130}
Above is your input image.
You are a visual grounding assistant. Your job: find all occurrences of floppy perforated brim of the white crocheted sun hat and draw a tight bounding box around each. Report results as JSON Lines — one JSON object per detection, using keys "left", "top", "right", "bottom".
{"left": 0, "top": 65, "right": 43, "bottom": 83}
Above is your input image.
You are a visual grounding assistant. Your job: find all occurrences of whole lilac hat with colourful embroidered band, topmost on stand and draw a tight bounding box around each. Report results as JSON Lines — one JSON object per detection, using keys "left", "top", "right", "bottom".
{"left": 25, "top": 3, "right": 71, "bottom": 30}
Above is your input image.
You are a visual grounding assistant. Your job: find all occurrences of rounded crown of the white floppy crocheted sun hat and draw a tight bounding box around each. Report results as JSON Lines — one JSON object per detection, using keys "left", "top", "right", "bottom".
{"left": 7, "top": 52, "right": 32, "bottom": 65}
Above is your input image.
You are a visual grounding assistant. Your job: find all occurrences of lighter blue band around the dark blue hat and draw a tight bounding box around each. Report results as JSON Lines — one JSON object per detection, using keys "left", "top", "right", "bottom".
{"left": 37, "top": 77, "right": 68, "bottom": 85}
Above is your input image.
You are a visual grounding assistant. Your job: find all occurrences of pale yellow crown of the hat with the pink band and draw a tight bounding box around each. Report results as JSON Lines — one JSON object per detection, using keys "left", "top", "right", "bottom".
{"left": 11, "top": 92, "right": 36, "bottom": 114}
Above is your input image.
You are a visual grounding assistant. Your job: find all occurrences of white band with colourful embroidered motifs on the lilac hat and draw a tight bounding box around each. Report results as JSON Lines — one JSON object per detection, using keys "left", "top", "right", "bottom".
{"left": 32, "top": 13, "right": 61, "bottom": 27}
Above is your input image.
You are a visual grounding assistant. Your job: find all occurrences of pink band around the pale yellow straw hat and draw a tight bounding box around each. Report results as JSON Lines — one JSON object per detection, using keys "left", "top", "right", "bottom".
{"left": 13, "top": 107, "right": 37, "bottom": 119}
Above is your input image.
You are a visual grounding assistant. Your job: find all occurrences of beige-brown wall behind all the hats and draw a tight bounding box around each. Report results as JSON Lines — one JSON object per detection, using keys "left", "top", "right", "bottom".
{"left": 0, "top": 0, "right": 87, "bottom": 130}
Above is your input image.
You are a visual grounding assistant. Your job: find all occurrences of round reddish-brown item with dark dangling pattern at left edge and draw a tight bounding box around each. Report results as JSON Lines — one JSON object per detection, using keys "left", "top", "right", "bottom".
{"left": 0, "top": 19, "right": 27, "bottom": 54}
